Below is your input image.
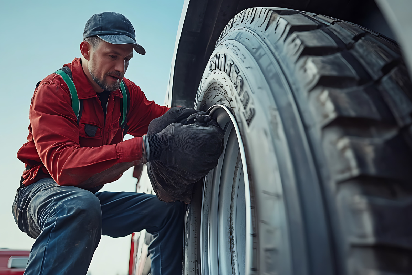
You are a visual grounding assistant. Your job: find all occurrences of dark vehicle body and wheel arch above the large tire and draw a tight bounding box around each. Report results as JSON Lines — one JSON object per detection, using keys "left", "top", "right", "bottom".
{"left": 167, "top": 0, "right": 412, "bottom": 106}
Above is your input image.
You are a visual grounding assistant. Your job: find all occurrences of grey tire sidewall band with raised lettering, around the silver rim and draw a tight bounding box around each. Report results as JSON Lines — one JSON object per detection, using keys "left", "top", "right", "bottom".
{"left": 195, "top": 40, "right": 295, "bottom": 274}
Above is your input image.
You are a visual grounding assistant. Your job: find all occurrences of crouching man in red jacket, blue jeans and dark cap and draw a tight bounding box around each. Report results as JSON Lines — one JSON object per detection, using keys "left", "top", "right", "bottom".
{"left": 13, "top": 12, "right": 219, "bottom": 275}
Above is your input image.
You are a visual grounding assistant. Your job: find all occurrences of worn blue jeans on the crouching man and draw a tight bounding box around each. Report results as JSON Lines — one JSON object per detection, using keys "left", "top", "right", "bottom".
{"left": 13, "top": 178, "right": 184, "bottom": 275}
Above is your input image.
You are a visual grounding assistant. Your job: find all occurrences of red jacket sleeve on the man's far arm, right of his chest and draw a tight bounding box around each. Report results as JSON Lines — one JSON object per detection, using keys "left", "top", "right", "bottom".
{"left": 126, "top": 80, "right": 169, "bottom": 137}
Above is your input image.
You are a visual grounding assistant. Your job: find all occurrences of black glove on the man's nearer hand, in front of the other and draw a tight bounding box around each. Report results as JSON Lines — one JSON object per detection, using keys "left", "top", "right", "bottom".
{"left": 146, "top": 121, "right": 223, "bottom": 178}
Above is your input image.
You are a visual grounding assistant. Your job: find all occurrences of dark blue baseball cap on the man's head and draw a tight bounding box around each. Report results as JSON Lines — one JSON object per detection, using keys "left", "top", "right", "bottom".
{"left": 83, "top": 12, "right": 146, "bottom": 54}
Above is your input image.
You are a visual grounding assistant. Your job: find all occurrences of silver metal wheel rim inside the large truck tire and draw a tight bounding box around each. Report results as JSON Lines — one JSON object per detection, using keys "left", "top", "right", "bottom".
{"left": 200, "top": 105, "right": 253, "bottom": 274}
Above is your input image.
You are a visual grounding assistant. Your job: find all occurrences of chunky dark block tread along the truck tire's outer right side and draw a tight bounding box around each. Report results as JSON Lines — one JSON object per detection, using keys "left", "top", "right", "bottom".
{"left": 206, "top": 8, "right": 412, "bottom": 275}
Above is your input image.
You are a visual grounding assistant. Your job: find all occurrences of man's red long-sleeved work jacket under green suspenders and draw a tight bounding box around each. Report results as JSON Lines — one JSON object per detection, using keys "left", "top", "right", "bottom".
{"left": 17, "top": 58, "right": 168, "bottom": 191}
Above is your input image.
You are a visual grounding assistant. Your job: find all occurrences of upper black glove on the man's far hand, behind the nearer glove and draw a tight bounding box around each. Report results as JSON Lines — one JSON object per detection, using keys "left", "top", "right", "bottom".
{"left": 147, "top": 107, "right": 197, "bottom": 135}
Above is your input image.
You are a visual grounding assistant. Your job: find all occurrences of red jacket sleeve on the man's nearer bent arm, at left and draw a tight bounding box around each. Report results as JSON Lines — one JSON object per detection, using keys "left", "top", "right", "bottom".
{"left": 29, "top": 75, "right": 142, "bottom": 188}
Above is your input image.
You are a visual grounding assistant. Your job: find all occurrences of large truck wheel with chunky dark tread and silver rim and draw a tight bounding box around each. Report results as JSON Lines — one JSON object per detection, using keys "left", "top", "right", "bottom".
{"left": 184, "top": 8, "right": 412, "bottom": 275}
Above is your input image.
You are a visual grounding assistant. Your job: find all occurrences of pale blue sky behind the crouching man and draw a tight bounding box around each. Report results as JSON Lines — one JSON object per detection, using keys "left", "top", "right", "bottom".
{"left": 0, "top": 0, "right": 184, "bottom": 275}
